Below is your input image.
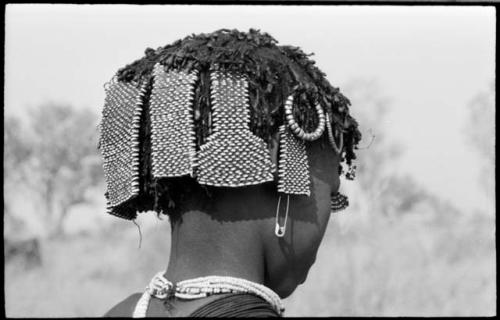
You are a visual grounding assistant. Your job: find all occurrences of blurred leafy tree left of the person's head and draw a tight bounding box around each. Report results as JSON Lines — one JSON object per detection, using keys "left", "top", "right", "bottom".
{"left": 21, "top": 104, "right": 102, "bottom": 236}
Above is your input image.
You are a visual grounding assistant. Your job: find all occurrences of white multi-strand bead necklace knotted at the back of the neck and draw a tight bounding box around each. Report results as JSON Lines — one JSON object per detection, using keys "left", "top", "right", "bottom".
{"left": 132, "top": 271, "right": 285, "bottom": 318}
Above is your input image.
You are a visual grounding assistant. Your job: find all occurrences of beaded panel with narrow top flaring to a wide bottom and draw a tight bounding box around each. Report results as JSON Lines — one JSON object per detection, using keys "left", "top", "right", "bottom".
{"left": 197, "top": 71, "right": 275, "bottom": 187}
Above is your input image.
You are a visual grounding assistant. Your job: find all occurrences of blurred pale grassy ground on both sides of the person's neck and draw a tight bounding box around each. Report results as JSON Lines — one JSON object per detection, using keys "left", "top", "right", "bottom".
{"left": 5, "top": 206, "right": 496, "bottom": 317}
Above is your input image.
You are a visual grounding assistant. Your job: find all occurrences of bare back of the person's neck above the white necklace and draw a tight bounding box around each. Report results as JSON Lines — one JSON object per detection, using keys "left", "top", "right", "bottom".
{"left": 166, "top": 210, "right": 265, "bottom": 284}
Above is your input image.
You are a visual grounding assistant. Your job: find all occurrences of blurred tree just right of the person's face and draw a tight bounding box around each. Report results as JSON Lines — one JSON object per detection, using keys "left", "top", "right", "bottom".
{"left": 343, "top": 79, "right": 430, "bottom": 218}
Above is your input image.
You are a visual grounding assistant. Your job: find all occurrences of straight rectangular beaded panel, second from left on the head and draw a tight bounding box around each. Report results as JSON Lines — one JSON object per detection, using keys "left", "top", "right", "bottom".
{"left": 150, "top": 63, "right": 198, "bottom": 178}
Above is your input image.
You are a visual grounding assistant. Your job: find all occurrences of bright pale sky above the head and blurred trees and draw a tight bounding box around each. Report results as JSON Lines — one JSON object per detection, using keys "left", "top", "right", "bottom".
{"left": 4, "top": 4, "right": 496, "bottom": 214}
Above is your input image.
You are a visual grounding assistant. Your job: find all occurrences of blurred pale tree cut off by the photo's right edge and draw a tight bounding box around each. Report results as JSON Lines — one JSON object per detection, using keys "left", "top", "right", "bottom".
{"left": 464, "top": 82, "right": 495, "bottom": 197}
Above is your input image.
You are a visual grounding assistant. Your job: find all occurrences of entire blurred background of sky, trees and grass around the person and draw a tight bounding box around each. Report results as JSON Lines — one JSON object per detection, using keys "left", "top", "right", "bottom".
{"left": 4, "top": 4, "right": 496, "bottom": 317}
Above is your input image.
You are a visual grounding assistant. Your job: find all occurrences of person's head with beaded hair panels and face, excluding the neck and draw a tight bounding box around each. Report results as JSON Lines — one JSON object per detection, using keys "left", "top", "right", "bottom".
{"left": 100, "top": 29, "right": 361, "bottom": 308}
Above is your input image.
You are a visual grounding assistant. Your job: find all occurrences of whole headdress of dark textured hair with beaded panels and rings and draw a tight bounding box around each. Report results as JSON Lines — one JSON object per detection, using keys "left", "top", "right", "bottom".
{"left": 100, "top": 29, "right": 361, "bottom": 219}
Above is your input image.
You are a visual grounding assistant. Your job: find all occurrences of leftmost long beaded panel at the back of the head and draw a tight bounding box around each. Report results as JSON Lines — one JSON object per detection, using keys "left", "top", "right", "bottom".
{"left": 99, "top": 80, "right": 147, "bottom": 219}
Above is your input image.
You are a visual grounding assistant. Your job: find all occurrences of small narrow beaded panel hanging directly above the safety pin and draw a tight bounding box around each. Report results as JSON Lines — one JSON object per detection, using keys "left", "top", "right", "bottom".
{"left": 278, "top": 125, "right": 311, "bottom": 196}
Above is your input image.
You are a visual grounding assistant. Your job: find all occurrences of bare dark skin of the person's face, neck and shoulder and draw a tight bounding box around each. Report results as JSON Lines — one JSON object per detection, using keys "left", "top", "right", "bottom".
{"left": 106, "top": 134, "right": 340, "bottom": 316}
